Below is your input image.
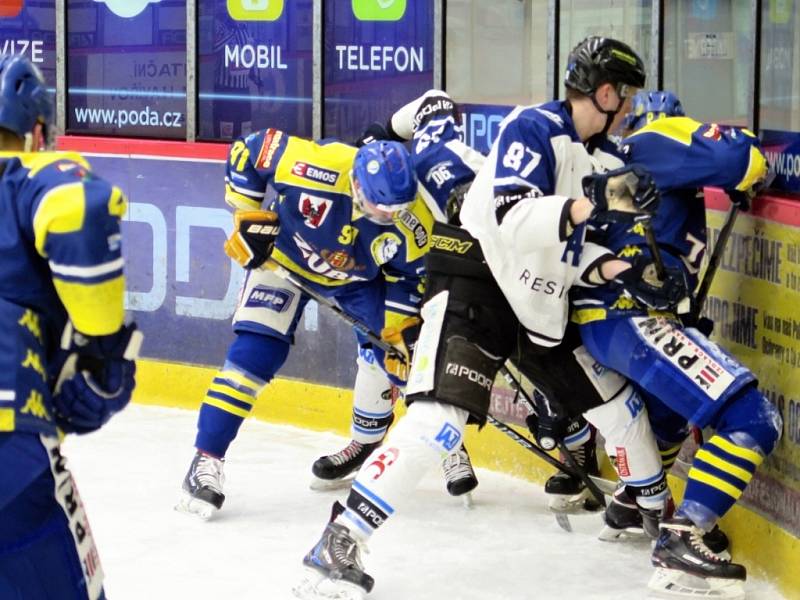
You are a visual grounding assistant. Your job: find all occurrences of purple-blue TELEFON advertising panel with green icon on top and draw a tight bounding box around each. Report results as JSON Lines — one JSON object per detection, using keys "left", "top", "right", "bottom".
{"left": 323, "top": 0, "right": 433, "bottom": 140}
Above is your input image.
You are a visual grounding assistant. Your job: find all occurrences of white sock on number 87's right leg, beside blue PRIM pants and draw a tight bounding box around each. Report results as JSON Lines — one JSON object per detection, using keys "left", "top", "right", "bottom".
{"left": 584, "top": 385, "right": 663, "bottom": 487}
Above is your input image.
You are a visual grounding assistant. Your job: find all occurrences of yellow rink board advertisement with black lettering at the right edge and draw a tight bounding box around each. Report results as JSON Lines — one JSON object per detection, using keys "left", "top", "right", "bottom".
{"left": 706, "top": 199, "right": 800, "bottom": 536}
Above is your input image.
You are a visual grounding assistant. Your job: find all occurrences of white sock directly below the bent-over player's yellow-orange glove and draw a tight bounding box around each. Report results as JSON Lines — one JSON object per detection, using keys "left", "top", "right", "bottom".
{"left": 351, "top": 347, "right": 394, "bottom": 444}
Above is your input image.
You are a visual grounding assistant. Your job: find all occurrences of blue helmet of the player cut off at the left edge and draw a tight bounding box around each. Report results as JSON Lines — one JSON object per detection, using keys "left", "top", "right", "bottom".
{"left": 0, "top": 54, "right": 53, "bottom": 138}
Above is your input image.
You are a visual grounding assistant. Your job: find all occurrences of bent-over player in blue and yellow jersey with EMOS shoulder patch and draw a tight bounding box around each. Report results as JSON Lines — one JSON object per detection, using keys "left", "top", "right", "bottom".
{"left": 178, "top": 112, "right": 460, "bottom": 518}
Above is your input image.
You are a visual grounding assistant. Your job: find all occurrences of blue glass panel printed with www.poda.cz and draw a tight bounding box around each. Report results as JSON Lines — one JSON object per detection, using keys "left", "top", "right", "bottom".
{"left": 67, "top": 0, "right": 186, "bottom": 139}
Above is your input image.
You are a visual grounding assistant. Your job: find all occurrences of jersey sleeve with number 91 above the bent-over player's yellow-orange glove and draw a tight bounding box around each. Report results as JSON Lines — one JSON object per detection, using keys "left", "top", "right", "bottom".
{"left": 225, "top": 129, "right": 289, "bottom": 210}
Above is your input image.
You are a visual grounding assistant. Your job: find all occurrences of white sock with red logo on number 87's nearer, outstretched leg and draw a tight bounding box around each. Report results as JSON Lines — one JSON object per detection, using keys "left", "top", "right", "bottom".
{"left": 336, "top": 401, "right": 469, "bottom": 539}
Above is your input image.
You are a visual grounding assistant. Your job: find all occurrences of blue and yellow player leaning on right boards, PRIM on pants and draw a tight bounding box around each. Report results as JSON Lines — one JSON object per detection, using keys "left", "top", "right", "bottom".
{"left": 574, "top": 92, "right": 782, "bottom": 594}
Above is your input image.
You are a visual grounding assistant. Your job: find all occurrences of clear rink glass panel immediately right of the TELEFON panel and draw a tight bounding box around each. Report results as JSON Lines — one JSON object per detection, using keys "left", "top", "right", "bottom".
{"left": 445, "top": 0, "right": 549, "bottom": 104}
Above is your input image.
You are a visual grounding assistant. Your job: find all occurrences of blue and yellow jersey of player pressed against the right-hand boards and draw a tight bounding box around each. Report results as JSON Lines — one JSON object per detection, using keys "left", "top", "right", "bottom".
{"left": 575, "top": 117, "right": 767, "bottom": 322}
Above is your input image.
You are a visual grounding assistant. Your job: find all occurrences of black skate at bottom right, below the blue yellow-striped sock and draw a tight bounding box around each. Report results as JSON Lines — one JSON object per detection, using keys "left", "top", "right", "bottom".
{"left": 648, "top": 517, "right": 747, "bottom": 600}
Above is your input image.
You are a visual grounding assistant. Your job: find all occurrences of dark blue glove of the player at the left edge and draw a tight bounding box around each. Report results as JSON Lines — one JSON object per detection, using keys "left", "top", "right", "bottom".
{"left": 53, "top": 360, "right": 136, "bottom": 433}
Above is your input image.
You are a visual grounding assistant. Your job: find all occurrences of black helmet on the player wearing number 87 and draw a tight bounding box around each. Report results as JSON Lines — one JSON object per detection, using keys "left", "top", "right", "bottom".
{"left": 564, "top": 35, "right": 646, "bottom": 97}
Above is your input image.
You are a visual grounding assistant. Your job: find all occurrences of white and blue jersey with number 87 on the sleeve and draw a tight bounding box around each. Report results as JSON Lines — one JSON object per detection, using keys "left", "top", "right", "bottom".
{"left": 461, "top": 102, "right": 623, "bottom": 347}
